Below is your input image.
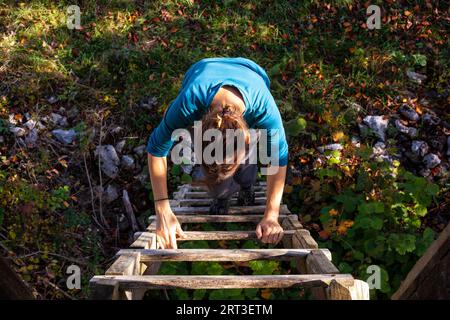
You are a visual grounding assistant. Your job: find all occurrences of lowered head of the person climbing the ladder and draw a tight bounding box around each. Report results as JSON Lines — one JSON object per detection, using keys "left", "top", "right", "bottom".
{"left": 202, "top": 104, "right": 250, "bottom": 186}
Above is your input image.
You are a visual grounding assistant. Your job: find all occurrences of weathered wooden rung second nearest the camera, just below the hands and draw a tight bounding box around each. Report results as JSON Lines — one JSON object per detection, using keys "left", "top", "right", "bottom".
{"left": 117, "top": 249, "right": 331, "bottom": 263}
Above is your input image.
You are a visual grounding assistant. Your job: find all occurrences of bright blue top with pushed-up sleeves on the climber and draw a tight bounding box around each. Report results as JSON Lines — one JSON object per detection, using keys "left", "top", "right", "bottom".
{"left": 147, "top": 58, "right": 288, "bottom": 166}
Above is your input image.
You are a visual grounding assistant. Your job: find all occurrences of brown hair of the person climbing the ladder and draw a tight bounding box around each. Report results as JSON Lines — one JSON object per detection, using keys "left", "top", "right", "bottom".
{"left": 200, "top": 105, "right": 250, "bottom": 189}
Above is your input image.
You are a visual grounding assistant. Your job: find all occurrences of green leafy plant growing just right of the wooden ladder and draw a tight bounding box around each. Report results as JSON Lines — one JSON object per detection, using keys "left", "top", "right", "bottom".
{"left": 318, "top": 149, "right": 438, "bottom": 297}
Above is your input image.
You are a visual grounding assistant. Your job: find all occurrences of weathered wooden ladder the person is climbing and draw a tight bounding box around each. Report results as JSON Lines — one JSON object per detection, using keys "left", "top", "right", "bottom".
{"left": 90, "top": 182, "right": 369, "bottom": 300}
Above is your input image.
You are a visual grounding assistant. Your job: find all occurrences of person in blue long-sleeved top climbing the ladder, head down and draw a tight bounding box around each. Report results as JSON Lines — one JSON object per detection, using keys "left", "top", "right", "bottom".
{"left": 147, "top": 58, "right": 288, "bottom": 249}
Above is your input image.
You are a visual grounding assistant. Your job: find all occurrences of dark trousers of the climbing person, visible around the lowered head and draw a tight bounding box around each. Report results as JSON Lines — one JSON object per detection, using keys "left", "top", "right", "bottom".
{"left": 192, "top": 164, "right": 258, "bottom": 199}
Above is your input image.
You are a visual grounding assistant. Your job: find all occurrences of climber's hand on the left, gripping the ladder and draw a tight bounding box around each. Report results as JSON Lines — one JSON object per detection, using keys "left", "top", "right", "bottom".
{"left": 156, "top": 201, "right": 186, "bottom": 249}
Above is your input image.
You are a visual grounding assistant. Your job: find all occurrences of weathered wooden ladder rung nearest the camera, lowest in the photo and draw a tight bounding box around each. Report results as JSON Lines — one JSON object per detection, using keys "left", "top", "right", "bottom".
{"left": 91, "top": 274, "right": 353, "bottom": 290}
